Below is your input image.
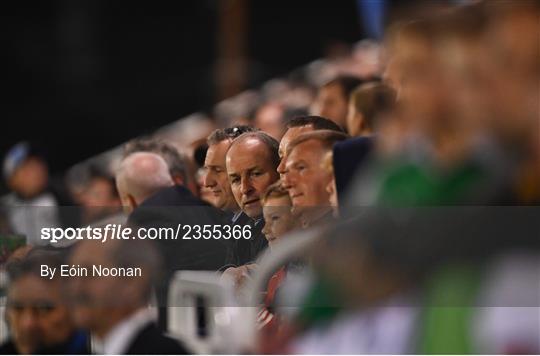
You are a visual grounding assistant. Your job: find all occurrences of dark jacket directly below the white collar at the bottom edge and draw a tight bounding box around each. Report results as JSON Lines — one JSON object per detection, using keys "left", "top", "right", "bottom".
{"left": 125, "top": 323, "right": 190, "bottom": 355}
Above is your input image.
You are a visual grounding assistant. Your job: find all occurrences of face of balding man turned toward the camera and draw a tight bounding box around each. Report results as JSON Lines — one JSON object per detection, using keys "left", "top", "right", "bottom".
{"left": 227, "top": 138, "right": 278, "bottom": 218}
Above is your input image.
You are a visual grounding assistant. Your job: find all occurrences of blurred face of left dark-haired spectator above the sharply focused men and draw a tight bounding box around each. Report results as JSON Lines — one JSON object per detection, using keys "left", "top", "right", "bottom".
{"left": 314, "top": 76, "right": 368, "bottom": 128}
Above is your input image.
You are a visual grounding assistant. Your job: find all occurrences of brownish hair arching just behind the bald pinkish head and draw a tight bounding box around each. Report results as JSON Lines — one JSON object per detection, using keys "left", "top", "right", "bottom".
{"left": 123, "top": 138, "right": 190, "bottom": 184}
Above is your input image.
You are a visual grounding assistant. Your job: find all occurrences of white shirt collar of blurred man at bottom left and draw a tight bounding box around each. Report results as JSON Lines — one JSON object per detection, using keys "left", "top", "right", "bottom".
{"left": 92, "top": 308, "right": 155, "bottom": 355}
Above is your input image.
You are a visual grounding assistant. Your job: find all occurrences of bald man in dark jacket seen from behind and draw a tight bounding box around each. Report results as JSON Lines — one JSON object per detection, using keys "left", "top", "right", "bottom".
{"left": 117, "top": 152, "right": 227, "bottom": 328}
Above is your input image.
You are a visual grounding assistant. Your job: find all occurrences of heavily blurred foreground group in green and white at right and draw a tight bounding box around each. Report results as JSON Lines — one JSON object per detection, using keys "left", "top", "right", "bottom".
{"left": 278, "top": 1, "right": 540, "bottom": 354}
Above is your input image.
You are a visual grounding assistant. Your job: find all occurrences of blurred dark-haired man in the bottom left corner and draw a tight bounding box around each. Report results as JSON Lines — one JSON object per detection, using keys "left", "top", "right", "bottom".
{"left": 0, "top": 248, "right": 90, "bottom": 355}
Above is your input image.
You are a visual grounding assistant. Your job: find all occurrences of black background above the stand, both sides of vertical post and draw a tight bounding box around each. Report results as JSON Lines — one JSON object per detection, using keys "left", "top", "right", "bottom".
{"left": 0, "top": 0, "right": 361, "bottom": 172}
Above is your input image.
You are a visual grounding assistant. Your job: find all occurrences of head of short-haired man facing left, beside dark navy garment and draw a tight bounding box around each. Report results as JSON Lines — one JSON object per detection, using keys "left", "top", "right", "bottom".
{"left": 283, "top": 130, "right": 347, "bottom": 227}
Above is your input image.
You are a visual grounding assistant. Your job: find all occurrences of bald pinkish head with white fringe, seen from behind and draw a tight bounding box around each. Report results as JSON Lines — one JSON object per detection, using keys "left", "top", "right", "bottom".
{"left": 116, "top": 152, "right": 174, "bottom": 212}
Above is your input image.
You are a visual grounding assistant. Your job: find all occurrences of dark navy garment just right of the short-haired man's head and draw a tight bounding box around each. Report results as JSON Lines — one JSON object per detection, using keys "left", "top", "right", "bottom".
{"left": 333, "top": 136, "right": 374, "bottom": 202}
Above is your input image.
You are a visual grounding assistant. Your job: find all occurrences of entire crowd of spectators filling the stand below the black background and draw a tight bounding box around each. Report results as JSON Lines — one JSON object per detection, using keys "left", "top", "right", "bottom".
{"left": 0, "top": 0, "right": 540, "bottom": 354}
